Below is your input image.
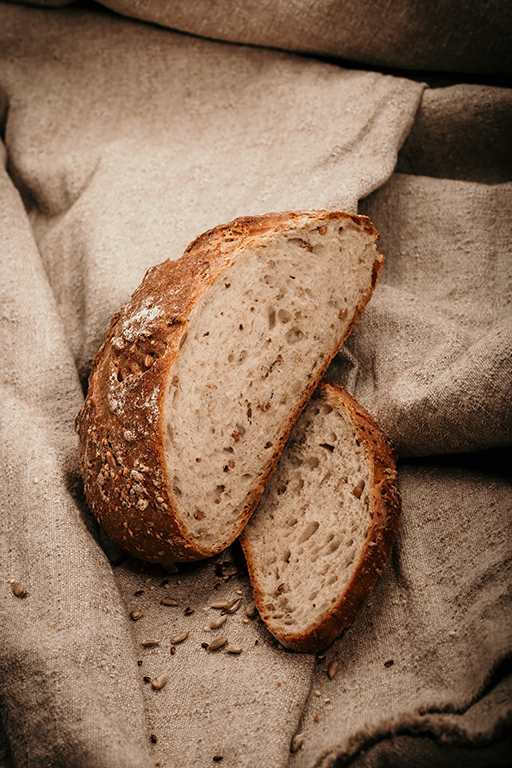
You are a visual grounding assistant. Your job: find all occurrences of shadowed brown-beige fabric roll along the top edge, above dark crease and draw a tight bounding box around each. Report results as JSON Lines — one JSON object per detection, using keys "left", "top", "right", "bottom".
{"left": 9, "top": 0, "right": 512, "bottom": 74}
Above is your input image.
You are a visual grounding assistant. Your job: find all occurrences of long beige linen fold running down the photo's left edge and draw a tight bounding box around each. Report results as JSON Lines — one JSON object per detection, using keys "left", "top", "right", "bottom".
{"left": 0, "top": 152, "right": 151, "bottom": 768}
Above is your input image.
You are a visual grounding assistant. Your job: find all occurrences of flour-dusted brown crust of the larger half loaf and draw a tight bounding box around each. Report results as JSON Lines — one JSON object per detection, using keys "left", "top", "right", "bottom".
{"left": 76, "top": 211, "right": 383, "bottom": 565}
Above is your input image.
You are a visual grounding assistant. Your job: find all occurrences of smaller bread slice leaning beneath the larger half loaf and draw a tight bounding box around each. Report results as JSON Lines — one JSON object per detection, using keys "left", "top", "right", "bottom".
{"left": 241, "top": 380, "right": 400, "bottom": 653}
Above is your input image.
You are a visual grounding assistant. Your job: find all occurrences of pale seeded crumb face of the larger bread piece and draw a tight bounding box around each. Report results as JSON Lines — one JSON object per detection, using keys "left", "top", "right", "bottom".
{"left": 165, "top": 219, "right": 375, "bottom": 553}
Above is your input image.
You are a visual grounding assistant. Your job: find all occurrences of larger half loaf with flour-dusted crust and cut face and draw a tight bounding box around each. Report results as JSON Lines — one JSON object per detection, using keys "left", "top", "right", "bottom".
{"left": 76, "top": 211, "right": 383, "bottom": 564}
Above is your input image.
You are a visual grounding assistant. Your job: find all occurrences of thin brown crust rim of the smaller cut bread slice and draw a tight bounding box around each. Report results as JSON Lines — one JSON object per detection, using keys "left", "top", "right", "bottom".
{"left": 240, "top": 379, "right": 401, "bottom": 653}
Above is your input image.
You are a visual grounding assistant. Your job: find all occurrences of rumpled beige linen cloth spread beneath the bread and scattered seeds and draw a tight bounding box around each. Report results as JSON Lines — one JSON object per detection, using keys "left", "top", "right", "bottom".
{"left": 0, "top": 6, "right": 512, "bottom": 768}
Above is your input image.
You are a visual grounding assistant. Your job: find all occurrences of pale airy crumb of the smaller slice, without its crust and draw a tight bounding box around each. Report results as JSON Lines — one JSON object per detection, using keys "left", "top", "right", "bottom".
{"left": 244, "top": 393, "right": 373, "bottom": 635}
